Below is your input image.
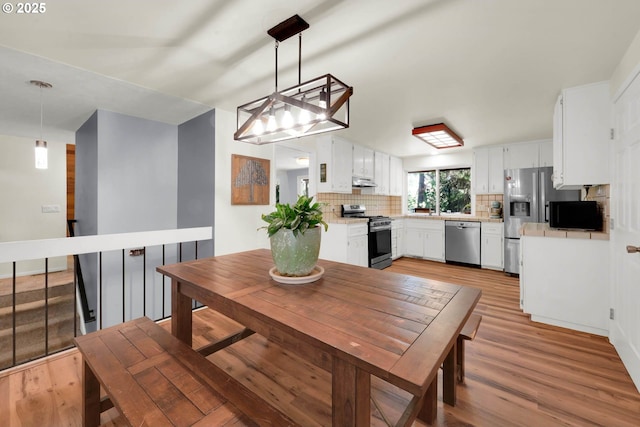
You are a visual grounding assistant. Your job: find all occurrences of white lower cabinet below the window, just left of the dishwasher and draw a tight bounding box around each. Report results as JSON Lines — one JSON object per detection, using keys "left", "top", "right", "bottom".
{"left": 404, "top": 219, "right": 444, "bottom": 261}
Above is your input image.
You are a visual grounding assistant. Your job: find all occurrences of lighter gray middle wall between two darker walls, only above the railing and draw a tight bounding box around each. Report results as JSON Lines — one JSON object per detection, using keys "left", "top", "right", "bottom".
{"left": 97, "top": 110, "right": 178, "bottom": 234}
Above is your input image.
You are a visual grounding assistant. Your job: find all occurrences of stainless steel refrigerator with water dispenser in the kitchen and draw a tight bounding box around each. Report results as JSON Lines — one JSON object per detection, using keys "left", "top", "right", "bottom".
{"left": 503, "top": 167, "right": 580, "bottom": 274}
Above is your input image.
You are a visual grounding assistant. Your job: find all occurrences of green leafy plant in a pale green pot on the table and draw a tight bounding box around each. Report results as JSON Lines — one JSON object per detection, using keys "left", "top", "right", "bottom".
{"left": 261, "top": 196, "right": 329, "bottom": 276}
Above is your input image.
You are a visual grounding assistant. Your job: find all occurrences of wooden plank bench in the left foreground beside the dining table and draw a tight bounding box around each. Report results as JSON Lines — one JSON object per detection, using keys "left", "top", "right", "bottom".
{"left": 76, "top": 317, "right": 297, "bottom": 427}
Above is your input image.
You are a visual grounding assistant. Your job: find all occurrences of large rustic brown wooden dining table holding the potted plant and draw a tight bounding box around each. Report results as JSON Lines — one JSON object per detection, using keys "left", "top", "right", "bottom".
{"left": 157, "top": 249, "right": 481, "bottom": 427}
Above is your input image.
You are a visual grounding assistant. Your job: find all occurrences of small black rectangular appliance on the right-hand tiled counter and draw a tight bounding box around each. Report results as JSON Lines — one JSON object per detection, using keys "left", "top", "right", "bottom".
{"left": 549, "top": 201, "right": 602, "bottom": 230}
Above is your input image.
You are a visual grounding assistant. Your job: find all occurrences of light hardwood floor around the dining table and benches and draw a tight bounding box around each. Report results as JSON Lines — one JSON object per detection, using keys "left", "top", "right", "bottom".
{"left": 0, "top": 258, "right": 640, "bottom": 427}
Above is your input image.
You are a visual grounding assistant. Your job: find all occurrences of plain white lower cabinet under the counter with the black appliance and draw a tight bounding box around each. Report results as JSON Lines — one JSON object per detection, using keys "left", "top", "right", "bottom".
{"left": 520, "top": 236, "right": 610, "bottom": 336}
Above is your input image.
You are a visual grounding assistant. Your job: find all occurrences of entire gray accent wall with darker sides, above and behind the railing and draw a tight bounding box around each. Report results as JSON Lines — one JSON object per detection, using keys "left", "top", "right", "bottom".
{"left": 76, "top": 110, "right": 215, "bottom": 330}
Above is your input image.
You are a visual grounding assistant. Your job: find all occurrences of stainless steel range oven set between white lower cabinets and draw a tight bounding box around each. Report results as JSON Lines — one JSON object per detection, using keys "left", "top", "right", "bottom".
{"left": 342, "top": 205, "right": 392, "bottom": 270}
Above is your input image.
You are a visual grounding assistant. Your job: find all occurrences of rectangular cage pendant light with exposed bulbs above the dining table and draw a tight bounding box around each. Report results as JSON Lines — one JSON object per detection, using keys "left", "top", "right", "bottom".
{"left": 233, "top": 15, "right": 353, "bottom": 144}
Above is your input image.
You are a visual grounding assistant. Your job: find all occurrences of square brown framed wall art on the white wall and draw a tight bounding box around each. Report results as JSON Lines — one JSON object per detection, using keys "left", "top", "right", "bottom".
{"left": 231, "top": 154, "right": 270, "bottom": 205}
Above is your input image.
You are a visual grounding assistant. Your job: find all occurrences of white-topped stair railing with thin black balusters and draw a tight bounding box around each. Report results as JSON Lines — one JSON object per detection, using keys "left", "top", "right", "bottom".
{"left": 0, "top": 227, "right": 213, "bottom": 370}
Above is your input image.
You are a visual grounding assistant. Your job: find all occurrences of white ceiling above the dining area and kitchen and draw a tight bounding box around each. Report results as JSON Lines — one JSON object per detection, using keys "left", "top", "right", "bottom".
{"left": 0, "top": 0, "right": 640, "bottom": 157}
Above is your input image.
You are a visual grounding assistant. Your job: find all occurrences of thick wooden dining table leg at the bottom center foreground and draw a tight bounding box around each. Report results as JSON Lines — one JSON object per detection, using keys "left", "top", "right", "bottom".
{"left": 331, "top": 357, "right": 371, "bottom": 427}
